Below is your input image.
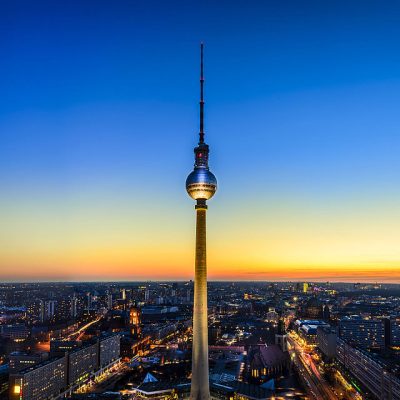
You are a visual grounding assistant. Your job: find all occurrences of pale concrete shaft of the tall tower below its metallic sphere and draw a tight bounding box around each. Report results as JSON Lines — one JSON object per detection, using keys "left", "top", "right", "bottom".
{"left": 190, "top": 205, "right": 210, "bottom": 400}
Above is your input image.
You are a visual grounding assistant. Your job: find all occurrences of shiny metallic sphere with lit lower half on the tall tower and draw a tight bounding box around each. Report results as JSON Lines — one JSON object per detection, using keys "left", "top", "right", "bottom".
{"left": 186, "top": 168, "right": 217, "bottom": 200}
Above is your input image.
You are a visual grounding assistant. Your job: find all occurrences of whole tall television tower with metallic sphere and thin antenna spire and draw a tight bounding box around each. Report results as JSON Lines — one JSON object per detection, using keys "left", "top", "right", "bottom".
{"left": 186, "top": 44, "right": 217, "bottom": 400}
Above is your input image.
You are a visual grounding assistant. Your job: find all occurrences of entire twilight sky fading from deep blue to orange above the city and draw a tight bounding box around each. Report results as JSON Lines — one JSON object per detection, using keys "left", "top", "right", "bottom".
{"left": 0, "top": 0, "right": 400, "bottom": 282}
